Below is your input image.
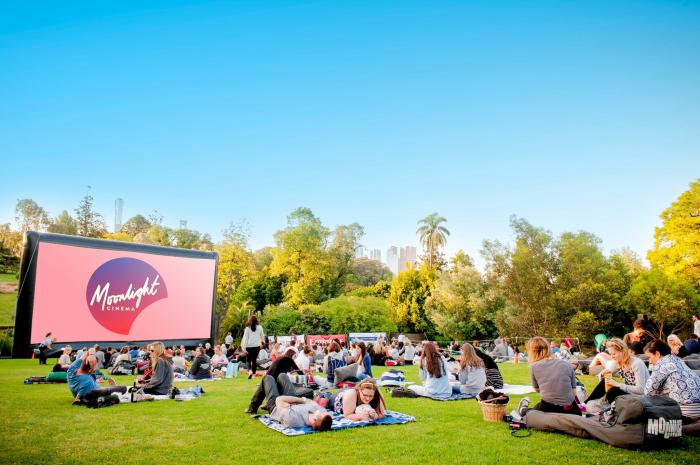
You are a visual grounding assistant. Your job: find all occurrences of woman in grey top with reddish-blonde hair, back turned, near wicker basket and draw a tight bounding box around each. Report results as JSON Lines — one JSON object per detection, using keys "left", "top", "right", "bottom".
{"left": 518, "top": 337, "right": 581, "bottom": 415}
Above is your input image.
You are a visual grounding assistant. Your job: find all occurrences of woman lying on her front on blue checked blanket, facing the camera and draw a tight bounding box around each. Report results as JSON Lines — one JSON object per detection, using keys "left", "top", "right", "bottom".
{"left": 328, "top": 378, "right": 386, "bottom": 421}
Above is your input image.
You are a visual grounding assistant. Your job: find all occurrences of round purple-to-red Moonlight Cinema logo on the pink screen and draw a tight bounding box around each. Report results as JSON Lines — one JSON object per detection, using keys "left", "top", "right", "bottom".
{"left": 85, "top": 258, "right": 168, "bottom": 334}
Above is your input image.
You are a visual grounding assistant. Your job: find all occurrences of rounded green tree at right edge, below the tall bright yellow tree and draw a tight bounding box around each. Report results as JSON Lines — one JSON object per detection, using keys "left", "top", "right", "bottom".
{"left": 625, "top": 268, "right": 700, "bottom": 339}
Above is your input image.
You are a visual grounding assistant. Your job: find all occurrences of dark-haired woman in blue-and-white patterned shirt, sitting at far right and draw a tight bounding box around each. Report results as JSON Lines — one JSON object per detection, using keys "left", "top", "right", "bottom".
{"left": 644, "top": 340, "right": 700, "bottom": 421}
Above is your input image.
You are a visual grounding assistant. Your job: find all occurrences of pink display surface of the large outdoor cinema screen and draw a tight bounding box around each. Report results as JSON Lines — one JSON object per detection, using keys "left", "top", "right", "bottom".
{"left": 31, "top": 242, "right": 215, "bottom": 344}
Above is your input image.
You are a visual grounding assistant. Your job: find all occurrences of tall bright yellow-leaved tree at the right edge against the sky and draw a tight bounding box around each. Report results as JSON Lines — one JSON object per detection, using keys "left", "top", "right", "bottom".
{"left": 647, "top": 179, "right": 700, "bottom": 290}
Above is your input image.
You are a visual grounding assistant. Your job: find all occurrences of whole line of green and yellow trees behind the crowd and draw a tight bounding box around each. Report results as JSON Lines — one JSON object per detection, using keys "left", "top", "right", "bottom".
{"left": 0, "top": 179, "right": 700, "bottom": 340}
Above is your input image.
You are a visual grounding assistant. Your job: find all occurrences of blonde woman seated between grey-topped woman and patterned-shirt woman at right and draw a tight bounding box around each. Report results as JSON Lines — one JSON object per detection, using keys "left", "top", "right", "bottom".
{"left": 588, "top": 338, "right": 649, "bottom": 402}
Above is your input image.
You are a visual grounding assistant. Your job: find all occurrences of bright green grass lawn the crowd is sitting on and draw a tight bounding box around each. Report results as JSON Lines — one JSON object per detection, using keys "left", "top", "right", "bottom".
{"left": 0, "top": 360, "right": 700, "bottom": 465}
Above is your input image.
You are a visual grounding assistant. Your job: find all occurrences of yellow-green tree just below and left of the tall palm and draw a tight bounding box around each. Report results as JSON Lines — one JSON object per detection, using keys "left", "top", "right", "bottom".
{"left": 387, "top": 264, "right": 435, "bottom": 334}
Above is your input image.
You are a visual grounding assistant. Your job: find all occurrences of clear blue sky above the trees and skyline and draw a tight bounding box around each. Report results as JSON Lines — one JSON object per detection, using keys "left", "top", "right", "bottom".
{"left": 0, "top": 0, "right": 700, "bottom": 266}
